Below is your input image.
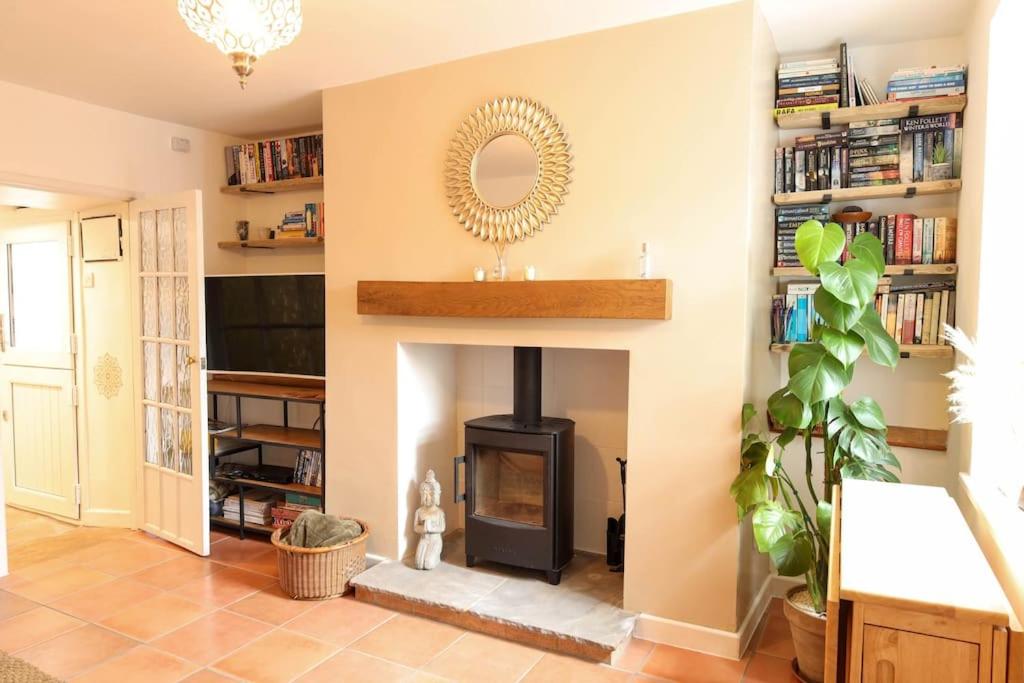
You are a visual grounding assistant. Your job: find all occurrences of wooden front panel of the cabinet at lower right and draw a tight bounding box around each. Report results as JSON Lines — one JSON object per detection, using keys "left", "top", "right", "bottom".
{"left": 861, "top": 626, "right": 979, "bottom": 683}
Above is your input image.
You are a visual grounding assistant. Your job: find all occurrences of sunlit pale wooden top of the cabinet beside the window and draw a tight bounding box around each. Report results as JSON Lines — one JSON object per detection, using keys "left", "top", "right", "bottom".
{"left": 840, "top": 479, "right": 1010, "bottom": 626}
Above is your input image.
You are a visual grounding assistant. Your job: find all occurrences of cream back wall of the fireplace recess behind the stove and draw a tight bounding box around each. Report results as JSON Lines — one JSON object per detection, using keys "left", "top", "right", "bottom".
{"left": 444, "top": 346, "right": 630, "bottom": 555}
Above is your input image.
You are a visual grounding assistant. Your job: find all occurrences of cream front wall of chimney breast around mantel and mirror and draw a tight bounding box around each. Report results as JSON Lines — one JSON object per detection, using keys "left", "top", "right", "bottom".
{"left": 324, "top": 2, "right": 767, "bottom": 631}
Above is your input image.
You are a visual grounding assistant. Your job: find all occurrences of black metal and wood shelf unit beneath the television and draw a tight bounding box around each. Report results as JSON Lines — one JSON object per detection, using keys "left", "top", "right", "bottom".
{"left": 207, "top": 375, "right": 327, "bottom": 539}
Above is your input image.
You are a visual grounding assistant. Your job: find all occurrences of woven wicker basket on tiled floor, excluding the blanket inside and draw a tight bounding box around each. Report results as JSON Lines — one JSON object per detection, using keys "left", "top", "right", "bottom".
{"left": 270, "top": 518, "right": 370, "bottom": 600}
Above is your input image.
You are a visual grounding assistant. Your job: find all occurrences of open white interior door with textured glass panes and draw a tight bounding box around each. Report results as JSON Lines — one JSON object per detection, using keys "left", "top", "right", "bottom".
{"left": 131, "top": 190, "right": 210, "bottom": 555}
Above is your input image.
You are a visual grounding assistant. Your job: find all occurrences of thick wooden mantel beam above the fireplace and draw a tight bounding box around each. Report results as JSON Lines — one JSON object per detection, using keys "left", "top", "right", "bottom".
{"left": 356, "top": 280, "right": 672, "bottom": 321}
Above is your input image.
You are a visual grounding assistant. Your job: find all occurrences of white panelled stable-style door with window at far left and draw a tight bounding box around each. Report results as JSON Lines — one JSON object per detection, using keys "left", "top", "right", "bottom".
{"left": 0, "top": 219, "right": 79, "bottom": 519}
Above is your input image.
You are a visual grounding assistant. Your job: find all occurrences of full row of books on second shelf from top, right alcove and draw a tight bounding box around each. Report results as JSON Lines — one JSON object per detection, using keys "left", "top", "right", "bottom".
{"left": 774, "top": 114, "right": 964, "bottom": 194}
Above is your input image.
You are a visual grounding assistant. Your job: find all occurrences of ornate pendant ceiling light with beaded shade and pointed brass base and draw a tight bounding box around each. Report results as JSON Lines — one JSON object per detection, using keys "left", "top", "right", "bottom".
{"left": 178, "top": 0, "right": 302, "bottom": 90}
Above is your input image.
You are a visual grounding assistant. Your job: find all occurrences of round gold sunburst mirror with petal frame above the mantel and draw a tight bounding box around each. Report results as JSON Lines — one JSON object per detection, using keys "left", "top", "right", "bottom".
{"left": 444, "top": 97, "right": 572, "bottom": 257}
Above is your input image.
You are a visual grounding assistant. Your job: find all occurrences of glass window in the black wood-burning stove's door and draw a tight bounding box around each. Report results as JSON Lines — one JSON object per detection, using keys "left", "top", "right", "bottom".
{"left": 472, "top": 446, "right": 545, "bottom": 526}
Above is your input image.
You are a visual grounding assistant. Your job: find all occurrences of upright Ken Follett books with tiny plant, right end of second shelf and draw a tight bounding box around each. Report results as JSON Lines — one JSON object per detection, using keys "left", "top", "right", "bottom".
{"left": 899, "top": 113, "right": 964, "bottom": 182}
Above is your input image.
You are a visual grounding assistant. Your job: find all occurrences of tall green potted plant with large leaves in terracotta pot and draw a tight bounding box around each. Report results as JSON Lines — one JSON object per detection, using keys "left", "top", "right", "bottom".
{"left": 729, "top": 220, "right": 899, "bottom": 681}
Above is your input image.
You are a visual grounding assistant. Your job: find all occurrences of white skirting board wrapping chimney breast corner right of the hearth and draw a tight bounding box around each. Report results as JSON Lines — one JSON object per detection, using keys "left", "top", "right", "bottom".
{"left": 633, "top": 575, "right": 777, "bottom": 659}
